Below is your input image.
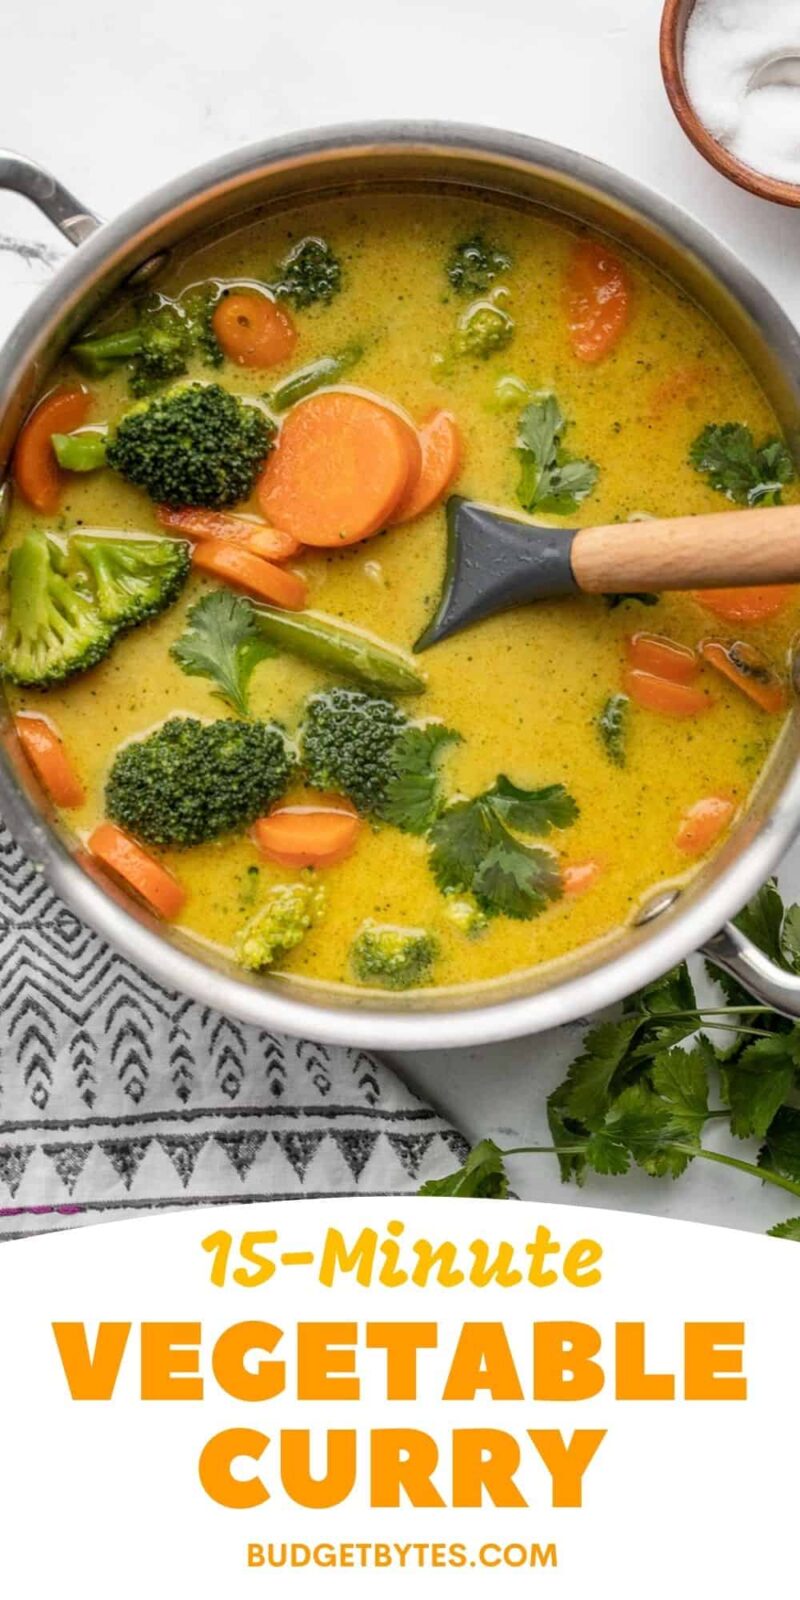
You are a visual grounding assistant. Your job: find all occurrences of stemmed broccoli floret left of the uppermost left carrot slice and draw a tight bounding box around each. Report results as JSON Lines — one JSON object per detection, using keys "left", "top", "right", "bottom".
{"left": 70, "top": 283, "right": 222, "bottom": 398}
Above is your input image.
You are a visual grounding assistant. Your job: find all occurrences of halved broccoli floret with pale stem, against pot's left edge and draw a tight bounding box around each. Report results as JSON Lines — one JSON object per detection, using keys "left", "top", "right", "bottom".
{"left": 2, "top": 533, "right": 114, "bottom": 688}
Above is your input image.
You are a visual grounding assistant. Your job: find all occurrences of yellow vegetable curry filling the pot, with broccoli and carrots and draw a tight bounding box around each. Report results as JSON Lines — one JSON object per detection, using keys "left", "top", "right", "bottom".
{"left": 2, "top": 184, "right": 798, "bottom": 990}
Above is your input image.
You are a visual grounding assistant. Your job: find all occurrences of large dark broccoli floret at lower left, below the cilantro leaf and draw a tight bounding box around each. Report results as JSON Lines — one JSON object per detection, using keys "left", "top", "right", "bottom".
{"left": 106, "top": 717, "right": 294, "bottom": 848}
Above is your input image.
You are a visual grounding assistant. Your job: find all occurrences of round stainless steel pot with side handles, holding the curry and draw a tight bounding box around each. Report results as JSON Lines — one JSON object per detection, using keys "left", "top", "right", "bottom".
{"left": 0, "top": 123, "right": 800, "bottom": 1050}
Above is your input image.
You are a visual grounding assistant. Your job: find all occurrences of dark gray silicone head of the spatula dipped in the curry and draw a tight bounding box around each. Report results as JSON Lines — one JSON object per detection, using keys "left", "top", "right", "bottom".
{"left": 414, "top": 494, "right": 578, "bottom": 651}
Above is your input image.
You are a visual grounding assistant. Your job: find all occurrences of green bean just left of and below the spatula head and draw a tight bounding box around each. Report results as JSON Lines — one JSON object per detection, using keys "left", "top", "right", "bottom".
{"left": 253, "top": 605, "right": 426, "bottom": 694}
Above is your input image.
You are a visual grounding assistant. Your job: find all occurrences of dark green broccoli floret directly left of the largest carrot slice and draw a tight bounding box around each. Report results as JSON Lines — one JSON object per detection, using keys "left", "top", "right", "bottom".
{"left": 106, "top": 384, "right": 275, "bottom": 509}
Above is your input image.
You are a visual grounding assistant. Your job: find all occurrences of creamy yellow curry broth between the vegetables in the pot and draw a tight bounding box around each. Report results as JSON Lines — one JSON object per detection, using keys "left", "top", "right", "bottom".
{"left": 4, "top": 195, "right": 797, "bottom": 984}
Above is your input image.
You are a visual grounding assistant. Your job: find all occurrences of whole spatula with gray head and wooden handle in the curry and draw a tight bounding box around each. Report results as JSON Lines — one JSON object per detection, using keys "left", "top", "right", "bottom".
{"left": 414, "top": 494, "right": 800, "bottom": 651}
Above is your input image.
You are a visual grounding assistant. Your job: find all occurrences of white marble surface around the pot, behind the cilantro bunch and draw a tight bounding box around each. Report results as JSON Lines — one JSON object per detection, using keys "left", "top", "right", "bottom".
{"left": 0, "top": 0, "right": 800, "bottom": 1227}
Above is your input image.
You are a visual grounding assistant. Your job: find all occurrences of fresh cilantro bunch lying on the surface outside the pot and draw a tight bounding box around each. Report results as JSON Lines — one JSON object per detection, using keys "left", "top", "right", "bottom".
{"left": 422, "top": 882, "right": 800, "bottom": 1240}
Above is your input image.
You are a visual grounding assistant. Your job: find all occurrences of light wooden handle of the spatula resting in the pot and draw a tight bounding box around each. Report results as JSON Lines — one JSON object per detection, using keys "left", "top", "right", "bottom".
{"left": 571, "top": 506, "right": 800, "bottom": 595}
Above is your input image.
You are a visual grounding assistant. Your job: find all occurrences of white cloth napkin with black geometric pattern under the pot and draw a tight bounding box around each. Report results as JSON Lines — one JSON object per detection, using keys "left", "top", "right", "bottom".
{"left": 0, "top": 824, "right": 467, "bottom": 1238}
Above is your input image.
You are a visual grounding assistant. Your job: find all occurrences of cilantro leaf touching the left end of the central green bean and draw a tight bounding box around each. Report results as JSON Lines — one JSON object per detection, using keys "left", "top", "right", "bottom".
{"left": 170, "top": 589, "right": 277, "bottom": 717}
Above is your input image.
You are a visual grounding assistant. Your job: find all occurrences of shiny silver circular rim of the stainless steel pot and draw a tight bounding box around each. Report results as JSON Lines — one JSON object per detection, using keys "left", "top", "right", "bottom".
{"left": 0, "top": 122, "right": 800, "bottom": 1050}
